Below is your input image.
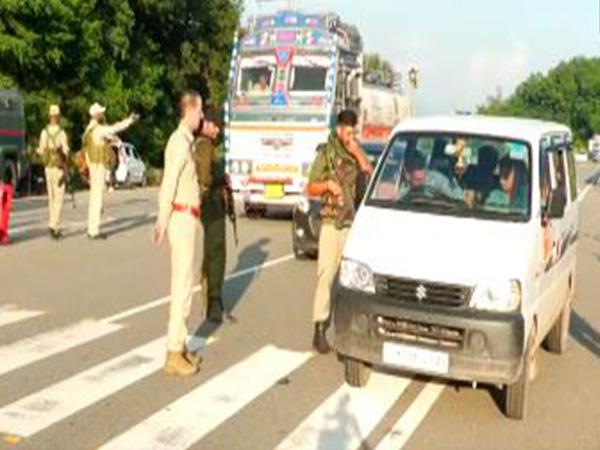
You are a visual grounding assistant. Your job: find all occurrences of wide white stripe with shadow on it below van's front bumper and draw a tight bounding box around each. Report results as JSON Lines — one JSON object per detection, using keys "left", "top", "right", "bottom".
{"left": 276, "top": 374, "right": 412, "bottom": 450}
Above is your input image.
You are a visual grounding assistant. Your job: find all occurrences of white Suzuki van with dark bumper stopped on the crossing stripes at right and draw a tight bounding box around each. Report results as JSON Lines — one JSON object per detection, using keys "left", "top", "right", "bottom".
{"left": 334, "top": 116, "right": 578, "bottom": 419}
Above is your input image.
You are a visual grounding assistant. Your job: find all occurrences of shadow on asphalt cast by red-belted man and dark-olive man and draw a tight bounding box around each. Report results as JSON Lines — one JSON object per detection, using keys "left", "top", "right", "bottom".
{"left": 194, "top": 238, "right": 271, "bottom": 337}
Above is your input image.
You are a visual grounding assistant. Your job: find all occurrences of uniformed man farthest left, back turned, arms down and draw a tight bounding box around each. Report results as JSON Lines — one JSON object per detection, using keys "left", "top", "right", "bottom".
{"left": 37, "top": 105, "right": 69, "bottom": 240}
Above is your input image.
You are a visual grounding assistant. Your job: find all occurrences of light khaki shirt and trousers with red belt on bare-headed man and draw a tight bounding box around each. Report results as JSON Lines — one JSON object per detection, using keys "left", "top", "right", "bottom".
{"left": 159, "top": 125, "right": 200, "bottom": 352}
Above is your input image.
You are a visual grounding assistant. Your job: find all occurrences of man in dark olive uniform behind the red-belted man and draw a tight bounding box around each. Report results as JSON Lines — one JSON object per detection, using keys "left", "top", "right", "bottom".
{"left": 194, "top": 108, "right": 228, "bottom": 323}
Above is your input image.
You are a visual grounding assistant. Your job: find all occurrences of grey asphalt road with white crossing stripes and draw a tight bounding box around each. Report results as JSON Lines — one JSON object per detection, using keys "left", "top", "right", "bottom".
{"left": 0, "top": 165, "right": 600, "bottom": 450}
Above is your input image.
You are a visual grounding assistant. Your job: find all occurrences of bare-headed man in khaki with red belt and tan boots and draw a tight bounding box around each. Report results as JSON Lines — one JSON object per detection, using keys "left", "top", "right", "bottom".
{"left": 154, "top": 92, "right": 203, "bottom": 376}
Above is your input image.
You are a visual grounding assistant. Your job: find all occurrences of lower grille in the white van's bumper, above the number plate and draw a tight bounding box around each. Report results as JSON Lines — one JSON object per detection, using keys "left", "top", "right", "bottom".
{"left": 377, "top": 316, "right": 465, "bottom": 348}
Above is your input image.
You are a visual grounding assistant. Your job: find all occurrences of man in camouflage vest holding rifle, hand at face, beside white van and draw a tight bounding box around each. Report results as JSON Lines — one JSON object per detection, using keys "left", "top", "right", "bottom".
{"left": 308, "top": 110, "right": 373, "bottom": 354}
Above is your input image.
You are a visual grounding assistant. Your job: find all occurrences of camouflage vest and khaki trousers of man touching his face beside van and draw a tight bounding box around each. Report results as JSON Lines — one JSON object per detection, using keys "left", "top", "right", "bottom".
{"left": 309, "top": 133, "right": 359, "bottom": 322}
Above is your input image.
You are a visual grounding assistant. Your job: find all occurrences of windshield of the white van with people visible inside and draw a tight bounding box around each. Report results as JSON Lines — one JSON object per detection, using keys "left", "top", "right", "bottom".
{"left": 367, "top": 132, "right": 531, "bottom": 221}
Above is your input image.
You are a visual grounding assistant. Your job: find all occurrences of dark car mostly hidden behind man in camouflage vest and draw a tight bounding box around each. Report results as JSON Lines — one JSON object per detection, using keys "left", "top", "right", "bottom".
{"left": 292, "top": 143, "right": 384, "bottom": 259}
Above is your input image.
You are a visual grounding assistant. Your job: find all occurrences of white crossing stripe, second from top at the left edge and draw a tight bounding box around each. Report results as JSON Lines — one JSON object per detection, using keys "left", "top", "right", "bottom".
{"left": 0, "top": 320, "right": 123, "bottom": 375}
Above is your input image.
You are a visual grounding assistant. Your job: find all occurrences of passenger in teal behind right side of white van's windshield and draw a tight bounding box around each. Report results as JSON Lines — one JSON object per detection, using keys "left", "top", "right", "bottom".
{"left": 485, "top": 156, "right": 528, "bottom": 210}
